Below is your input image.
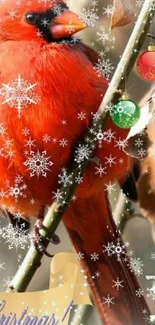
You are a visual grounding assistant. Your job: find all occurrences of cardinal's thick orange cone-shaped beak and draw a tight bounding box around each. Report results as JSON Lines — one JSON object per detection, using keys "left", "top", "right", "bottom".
{"left": 50, "top": 9, "right": 87, "bottom": 40}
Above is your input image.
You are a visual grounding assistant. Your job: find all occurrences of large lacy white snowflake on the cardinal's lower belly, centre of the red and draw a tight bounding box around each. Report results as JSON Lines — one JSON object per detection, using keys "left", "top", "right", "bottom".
{"left": 24, "top": 150, "right": 53, "bottom": 177}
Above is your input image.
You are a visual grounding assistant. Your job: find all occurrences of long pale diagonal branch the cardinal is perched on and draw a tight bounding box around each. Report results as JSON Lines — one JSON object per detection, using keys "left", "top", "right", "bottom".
{"left": 10, "top": 0, "right": 154, "bottom": 292}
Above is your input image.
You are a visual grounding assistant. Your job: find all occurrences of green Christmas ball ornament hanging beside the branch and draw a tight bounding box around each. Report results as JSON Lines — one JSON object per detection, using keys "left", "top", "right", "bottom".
{"left": 111, "top": 94, "right": 140, "bottom": 129}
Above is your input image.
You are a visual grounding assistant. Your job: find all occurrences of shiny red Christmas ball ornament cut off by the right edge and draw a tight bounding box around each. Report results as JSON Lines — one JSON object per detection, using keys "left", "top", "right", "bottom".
{"left": 136, "top": 45, "right": 155, "bottom": 81}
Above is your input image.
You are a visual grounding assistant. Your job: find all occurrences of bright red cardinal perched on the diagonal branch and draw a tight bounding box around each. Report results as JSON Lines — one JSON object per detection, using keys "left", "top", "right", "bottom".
{"left": 0, "top": 0, "right": 149, "bottom": 325}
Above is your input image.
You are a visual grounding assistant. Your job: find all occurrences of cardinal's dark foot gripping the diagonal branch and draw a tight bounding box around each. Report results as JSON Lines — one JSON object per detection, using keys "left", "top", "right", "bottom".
{"left": 32, "top": 219, "right": 60, "bottom": 257}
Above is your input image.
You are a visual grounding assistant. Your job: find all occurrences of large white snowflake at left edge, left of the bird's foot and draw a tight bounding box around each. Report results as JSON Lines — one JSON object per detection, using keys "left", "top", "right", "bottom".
{"left": 1, "top": 223, "right": 30, "bottom": 249}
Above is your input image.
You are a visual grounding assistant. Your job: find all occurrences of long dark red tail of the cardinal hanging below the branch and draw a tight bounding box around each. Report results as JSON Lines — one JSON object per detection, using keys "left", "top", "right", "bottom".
{"left": 64, "top": 193, "right": 149, "bottom": 325}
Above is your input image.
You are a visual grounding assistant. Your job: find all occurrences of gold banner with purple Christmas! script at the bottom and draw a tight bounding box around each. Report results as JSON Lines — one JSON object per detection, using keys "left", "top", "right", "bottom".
{"left": 0, "top": 253, "right": 92, "bottom": 325}
